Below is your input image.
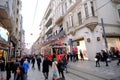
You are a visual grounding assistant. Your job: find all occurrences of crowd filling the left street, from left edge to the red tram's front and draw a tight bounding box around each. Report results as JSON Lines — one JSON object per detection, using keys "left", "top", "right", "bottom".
{"left": 0, "top": 55, "right": 67, "bottom": 80}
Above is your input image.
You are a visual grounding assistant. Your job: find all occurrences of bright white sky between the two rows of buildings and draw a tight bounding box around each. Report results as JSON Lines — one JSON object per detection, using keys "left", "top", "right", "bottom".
{"left": 21, "top": 0, "right": 50, "bottom": 48}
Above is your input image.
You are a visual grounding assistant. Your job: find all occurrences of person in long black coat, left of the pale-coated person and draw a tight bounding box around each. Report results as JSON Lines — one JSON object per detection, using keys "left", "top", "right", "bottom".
{"left": 42, "top": 57, "right": 50, "bottom": 80}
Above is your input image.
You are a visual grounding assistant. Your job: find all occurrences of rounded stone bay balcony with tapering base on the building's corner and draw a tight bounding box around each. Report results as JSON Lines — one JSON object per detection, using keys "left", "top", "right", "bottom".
{"left": 83, "top": 16, "right": 98, "bottom": 31}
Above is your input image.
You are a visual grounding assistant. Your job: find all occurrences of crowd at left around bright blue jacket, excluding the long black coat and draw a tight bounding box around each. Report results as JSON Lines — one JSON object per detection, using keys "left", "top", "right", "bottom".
{"left": 0, "top": 56, "right": 41, "bottom": 80}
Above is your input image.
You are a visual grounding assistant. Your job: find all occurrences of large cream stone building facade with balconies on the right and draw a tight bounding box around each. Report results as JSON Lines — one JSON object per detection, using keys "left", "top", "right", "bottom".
{"left": 39, "top": 0, "right": 120, "bottom": 60}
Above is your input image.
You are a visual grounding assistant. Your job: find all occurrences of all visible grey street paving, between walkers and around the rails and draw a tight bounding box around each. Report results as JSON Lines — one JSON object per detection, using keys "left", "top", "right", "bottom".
{"left": 1, "top": 61, "right": 120, "bottom": 80}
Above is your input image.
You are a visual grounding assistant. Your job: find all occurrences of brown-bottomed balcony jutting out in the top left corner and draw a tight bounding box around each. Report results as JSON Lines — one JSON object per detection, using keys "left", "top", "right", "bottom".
{"left": 0, "top": 0, "right": 12, "bottom": 32}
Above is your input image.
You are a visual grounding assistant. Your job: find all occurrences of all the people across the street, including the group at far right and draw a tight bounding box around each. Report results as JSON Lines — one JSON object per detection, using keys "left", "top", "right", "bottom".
{"left": 0, "top": 47, "right": 120, "bottom": 80}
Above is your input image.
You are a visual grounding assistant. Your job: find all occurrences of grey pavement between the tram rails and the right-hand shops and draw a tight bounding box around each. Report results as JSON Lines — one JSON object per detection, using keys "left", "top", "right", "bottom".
{"left": 68, "top": 61, "right": 120, "bottom": 80}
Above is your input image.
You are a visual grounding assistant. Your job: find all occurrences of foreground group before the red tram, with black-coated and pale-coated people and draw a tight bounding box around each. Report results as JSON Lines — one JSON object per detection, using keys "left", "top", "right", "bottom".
{"left": 42, "top": 55, "right": 68, "bottom": 80}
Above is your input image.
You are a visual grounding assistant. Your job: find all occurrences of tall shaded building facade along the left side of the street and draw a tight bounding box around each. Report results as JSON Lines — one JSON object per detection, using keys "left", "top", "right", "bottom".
{"left": 0, "top": 0, "right": 22, "bottom": 57}
